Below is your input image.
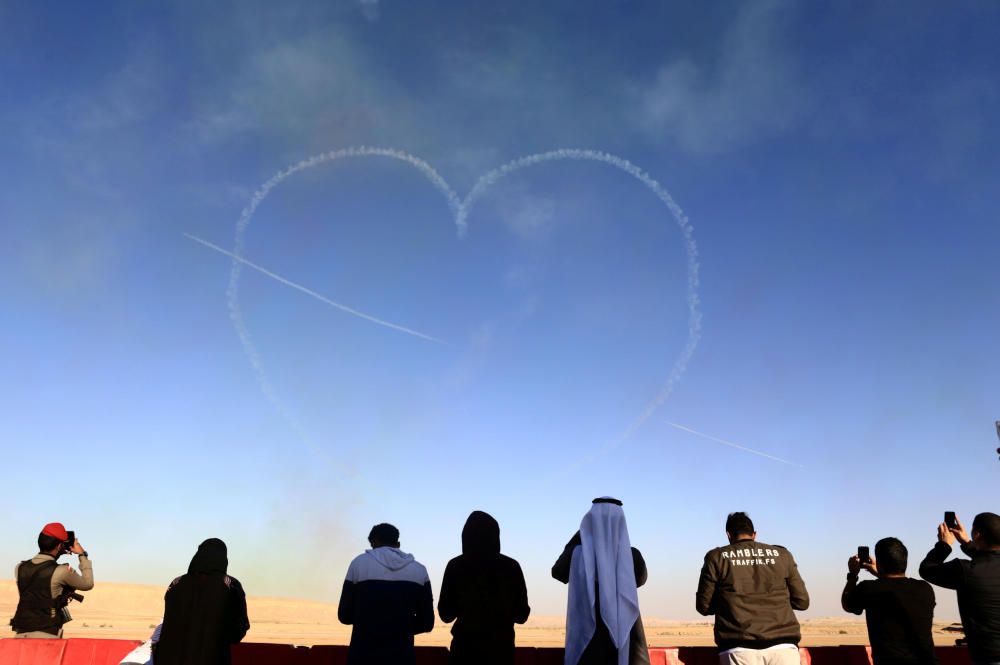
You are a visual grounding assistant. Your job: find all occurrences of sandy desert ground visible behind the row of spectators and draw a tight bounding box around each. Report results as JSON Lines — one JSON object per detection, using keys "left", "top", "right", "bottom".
{"left": 0, "top": 580, "right": 961, "bottom": 646}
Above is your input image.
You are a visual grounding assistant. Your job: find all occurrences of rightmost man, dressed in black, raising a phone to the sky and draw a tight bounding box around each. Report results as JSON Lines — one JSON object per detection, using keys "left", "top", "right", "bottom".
{"left": 920, "top": 513, "right": 1000, "bottom": 665}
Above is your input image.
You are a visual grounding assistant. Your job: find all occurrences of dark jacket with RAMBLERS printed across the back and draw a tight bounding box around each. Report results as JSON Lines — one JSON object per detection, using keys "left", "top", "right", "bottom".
{"left": 695, "top": 540, "right": 809, "bottom": 650}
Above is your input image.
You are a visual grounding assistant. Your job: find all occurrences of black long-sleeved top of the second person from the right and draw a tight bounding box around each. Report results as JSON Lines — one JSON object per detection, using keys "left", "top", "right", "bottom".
{"left": 844, "top": 577, "right": 936, "bottom": 665}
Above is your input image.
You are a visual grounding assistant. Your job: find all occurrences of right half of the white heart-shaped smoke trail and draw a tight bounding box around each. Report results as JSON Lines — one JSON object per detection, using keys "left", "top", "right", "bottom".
{"left": 455, "top": 148, "right": 701, "bottom": 473}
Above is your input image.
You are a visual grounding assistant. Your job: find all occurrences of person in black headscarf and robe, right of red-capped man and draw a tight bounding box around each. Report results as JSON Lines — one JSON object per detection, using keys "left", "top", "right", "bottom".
{"left": 153, "top": 538, "right": 250, "bottom": 665}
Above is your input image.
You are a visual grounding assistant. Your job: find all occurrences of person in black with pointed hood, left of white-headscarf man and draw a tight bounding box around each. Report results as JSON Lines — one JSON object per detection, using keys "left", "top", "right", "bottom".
{"left": 438, "top": 510, "right": 531, "bottom": 665}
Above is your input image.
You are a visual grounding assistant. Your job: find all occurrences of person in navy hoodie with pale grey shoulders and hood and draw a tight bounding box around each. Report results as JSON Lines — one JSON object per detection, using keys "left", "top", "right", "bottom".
{"left": 337, "top": 524, "right": 434, "bottom": 665}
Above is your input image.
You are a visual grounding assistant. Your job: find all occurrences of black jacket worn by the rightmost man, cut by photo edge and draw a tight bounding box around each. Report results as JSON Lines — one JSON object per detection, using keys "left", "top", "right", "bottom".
{"left": 920, "top": 542, "right": 1000, "bottom": 663}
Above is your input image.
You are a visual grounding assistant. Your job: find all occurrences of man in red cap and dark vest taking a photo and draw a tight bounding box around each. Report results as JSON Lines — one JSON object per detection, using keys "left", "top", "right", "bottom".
{"left": 10, "top": 522, "right": 94, "bottom": 639}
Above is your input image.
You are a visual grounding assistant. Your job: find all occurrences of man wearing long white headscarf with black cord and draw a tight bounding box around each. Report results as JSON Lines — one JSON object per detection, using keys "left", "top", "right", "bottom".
{"left": 552, "top": 497, "right": 649, "bottom": 665}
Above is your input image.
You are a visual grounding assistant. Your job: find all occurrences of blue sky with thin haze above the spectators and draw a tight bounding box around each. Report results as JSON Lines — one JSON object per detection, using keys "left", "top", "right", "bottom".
{"left": 0, "top": 0, "right": 1000, "bottom": 618}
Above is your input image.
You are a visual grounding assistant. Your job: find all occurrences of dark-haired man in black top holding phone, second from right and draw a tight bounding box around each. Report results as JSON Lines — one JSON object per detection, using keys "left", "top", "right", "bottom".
{"left": 840, "top": 538, "right": 937, "bottom": 665}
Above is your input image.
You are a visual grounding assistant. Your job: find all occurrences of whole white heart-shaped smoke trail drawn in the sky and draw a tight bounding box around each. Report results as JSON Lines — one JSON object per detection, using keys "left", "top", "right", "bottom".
{"left": 226, "top": 146, "right": 701, "bottom": 466}
